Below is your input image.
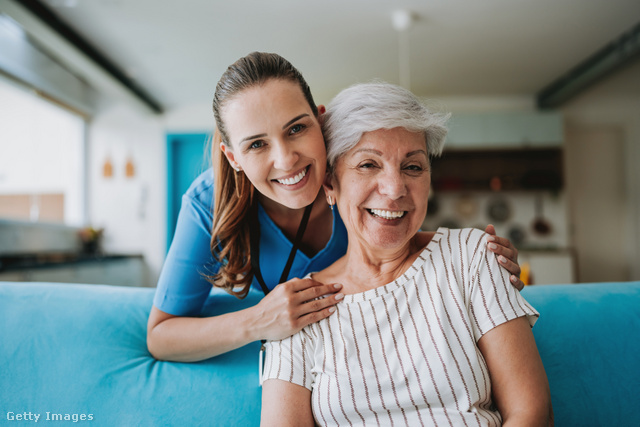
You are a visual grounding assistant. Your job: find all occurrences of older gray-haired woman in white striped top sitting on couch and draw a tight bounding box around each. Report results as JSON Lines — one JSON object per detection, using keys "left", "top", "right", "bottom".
{"left": 262, "top": 83, "right": 550, "bottom": 426}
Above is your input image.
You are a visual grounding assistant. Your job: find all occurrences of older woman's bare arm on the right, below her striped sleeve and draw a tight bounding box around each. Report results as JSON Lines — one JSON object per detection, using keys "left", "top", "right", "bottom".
{"left": 478, "top": 317, "right": 553, "bottom": 426}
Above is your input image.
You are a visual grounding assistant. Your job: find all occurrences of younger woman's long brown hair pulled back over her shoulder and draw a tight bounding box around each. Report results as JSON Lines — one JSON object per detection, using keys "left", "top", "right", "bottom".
{"left": 207, "top": 52, "right": 318, "bottom": 298}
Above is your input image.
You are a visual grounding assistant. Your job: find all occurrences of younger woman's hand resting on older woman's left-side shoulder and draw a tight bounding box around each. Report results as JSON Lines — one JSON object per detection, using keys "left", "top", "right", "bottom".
{"left": 255, "top": 278, "right": 344, "bottom": 340}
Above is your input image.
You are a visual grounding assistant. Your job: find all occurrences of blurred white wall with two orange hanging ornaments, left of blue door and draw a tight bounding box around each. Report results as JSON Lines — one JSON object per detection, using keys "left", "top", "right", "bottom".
{"left": 87, "top": 104, "right": 167, "bottom": 286}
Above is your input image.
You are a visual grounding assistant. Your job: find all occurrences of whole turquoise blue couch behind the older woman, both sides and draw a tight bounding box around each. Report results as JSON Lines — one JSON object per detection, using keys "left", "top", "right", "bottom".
{"left": 0, "top": 282, "right": 640, "bottom": 427}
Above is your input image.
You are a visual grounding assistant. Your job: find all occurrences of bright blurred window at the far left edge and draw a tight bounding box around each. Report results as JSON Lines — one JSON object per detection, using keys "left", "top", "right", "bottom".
{"left": 0, "top": 77, "right": 85, "bottom": 225}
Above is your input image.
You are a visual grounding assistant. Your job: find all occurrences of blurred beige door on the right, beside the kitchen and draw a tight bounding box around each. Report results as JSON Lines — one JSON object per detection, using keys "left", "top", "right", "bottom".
{"left": 565, "top": 125, "right": 630, "bottom": 282}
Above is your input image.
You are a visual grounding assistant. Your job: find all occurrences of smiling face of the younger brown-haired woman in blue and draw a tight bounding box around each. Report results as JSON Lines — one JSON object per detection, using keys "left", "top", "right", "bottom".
{"left": 221, "top": 79, "right": 327, "bottom": 209}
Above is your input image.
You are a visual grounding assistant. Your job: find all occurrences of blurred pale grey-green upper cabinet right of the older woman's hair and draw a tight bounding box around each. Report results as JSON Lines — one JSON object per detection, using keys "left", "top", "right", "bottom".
{"left": 445, "top": 112, "right": 563, "bottom": 150}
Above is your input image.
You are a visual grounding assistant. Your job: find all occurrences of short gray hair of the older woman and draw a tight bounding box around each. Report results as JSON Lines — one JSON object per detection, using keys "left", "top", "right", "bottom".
{"left": 323, "top": 82, "right": 450, "bottom": 171}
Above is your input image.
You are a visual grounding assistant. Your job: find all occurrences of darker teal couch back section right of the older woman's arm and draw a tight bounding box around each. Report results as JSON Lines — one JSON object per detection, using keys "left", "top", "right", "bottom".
{"left": 522, "top": 282, "right": 640, "bottom": 426}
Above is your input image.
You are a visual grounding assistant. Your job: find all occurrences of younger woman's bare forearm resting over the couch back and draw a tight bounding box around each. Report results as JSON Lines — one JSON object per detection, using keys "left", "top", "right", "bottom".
{"left": 147, "top": 307, "right": 261, "bottom": 362}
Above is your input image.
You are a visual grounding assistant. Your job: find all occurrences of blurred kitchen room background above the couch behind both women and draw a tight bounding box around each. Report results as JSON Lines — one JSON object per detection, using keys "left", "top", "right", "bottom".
{"left": 0, "top": 0, "right": 640, "bottom": 286}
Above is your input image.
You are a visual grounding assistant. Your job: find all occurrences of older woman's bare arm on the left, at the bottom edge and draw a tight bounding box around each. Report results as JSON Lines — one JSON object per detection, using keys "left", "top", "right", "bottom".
{"left": 260, "top": 379, "right": 314, "bottom": 427}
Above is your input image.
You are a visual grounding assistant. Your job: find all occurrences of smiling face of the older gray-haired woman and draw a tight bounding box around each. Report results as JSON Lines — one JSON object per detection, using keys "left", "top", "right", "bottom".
{"left": 325, "top": 128, "right": 431, "bottom": 251}
